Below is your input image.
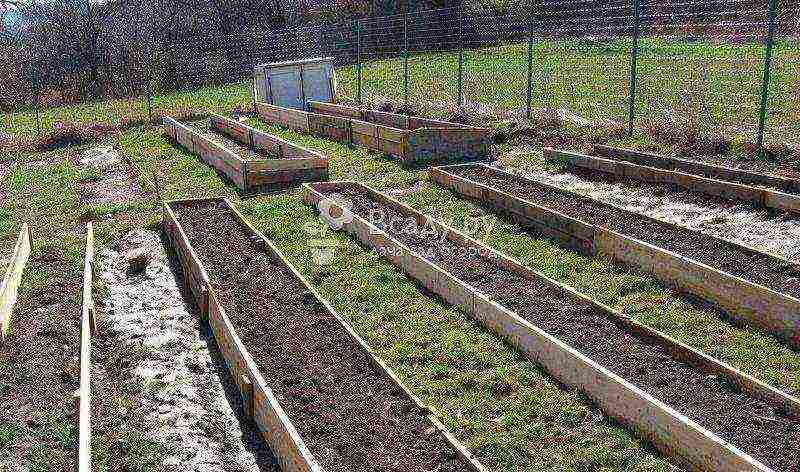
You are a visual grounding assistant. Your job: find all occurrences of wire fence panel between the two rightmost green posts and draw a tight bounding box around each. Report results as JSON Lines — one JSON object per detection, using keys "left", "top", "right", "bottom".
{"left": 636, "top": 0, "right": 767, "bottom": 142}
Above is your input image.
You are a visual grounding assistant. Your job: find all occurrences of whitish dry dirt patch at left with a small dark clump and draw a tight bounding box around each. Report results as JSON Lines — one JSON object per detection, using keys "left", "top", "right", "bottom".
{"left": 98, "top": 231, "right": 278, "bottom": 472}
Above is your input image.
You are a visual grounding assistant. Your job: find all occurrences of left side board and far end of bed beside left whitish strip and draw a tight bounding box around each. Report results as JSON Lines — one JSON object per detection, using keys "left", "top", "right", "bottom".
{"left": 162, "top": 198, "right": 323, "bottom": 472}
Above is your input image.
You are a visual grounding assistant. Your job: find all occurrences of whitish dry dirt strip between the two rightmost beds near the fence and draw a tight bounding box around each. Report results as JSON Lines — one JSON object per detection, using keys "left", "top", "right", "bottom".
{"left": 494, "top": 148, "right": 800, "bottom": 259}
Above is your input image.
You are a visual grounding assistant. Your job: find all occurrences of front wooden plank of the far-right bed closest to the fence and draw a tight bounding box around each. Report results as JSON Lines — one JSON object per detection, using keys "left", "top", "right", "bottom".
{"left": 544, "top": 148, "right": 800, "bottom": 212}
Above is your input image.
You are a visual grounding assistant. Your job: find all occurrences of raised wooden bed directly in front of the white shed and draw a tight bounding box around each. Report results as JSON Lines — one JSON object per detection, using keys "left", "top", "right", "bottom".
{"left": 256, "top": 101, "right": 491, "bottom": 164}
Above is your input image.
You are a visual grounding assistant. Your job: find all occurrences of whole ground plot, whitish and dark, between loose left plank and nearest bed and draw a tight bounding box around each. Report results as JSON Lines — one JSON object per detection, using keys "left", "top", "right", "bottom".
{"left": 92, "top": 230, "right": 279, "bottom": 472}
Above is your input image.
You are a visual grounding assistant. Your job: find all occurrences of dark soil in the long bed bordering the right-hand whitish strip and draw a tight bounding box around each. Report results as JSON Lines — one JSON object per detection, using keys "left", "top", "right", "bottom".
{"left": 451, "top": 166, "right": 800, "bottom": 297}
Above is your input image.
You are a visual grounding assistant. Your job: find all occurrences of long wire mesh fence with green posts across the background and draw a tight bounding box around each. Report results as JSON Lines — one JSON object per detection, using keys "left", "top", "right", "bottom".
{"left": 3, "top": 0, "right": 800, "bottom": 151}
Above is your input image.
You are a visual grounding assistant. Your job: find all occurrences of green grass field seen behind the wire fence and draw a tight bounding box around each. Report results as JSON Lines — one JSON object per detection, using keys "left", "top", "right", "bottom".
{"left": 2, "top": 38, "right": 800, "bottom": 142}
